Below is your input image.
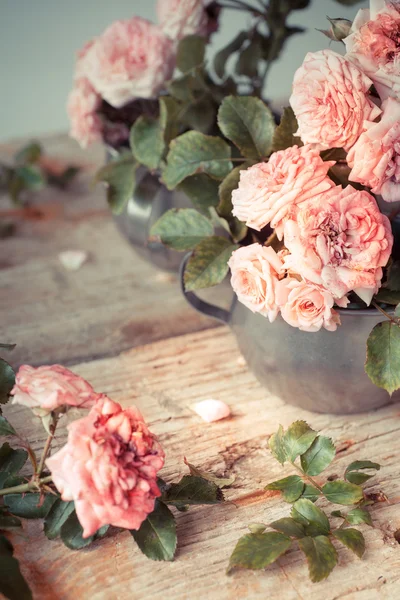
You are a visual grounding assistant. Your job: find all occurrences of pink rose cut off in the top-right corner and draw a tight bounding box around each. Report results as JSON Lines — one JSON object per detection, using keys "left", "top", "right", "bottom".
{"left": 343, "top": 0, "right": 400, "bottom": 101}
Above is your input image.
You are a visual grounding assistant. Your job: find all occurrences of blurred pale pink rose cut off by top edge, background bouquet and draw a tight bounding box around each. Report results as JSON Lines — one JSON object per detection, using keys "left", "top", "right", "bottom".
{"left": 157, "top": 0, "right": 208, "bottom": 40}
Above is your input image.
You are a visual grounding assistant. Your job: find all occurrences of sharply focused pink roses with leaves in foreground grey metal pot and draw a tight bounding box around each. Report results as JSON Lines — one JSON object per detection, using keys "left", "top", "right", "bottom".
{"left": 148, "top": 1, "right": 400, "bottom": 413}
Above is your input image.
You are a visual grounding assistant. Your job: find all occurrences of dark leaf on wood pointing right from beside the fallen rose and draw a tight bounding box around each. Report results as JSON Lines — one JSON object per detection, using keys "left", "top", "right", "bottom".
{"left": 162, "top": 475, "right": 224, "bottom": 505}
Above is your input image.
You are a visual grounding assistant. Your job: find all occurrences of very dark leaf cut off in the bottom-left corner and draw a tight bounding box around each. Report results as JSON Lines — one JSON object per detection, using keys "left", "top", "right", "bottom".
{"left": 0, "top": 535, "right": 32, "bottom": 600}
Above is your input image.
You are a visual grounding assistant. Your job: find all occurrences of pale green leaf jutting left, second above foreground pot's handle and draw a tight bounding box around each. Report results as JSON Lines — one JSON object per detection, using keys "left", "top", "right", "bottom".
{"left": 150, "top": 208, "right": 214, "bottom": 251}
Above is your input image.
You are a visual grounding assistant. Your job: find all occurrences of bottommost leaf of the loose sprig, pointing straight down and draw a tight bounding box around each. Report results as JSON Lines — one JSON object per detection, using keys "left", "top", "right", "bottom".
{"left": 299, "top": 535, "right": 338, "bottom": 583}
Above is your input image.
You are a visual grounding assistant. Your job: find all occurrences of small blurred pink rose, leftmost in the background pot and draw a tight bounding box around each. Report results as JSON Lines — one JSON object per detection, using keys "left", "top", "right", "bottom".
{"left": 67, "top": 77, "right": 103, "bottom": 148}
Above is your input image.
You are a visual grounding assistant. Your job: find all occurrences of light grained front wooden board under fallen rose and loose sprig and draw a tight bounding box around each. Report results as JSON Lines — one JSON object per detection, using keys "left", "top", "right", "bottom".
{"left": 2, "top": 328, "right": 400, "bottom": 600}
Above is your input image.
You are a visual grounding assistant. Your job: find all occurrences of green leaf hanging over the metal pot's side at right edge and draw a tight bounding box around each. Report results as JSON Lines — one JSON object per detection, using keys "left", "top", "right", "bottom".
{"left": 365, "top": 321, "right": 400, "bottom": 394}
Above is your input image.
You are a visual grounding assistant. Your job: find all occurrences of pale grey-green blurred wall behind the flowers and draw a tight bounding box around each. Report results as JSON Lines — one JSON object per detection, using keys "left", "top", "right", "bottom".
{"left": 0, "top": 0, "right": 367, "bottom": 141}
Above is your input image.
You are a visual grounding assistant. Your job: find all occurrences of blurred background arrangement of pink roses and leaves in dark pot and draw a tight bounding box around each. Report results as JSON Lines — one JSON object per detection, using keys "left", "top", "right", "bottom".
{"left": 68, "top": 0, "right": 318, "bottom": 270}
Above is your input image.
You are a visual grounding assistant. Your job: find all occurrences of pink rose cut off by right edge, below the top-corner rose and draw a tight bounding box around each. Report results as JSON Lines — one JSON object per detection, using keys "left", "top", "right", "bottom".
{"left": 347, "top": 97, "right": 400, "bottom": 202}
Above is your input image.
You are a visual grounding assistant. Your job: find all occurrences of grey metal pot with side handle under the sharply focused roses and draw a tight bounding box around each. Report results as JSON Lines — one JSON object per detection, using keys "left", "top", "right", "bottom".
{"left": 181, "top": 257, "right": 400, "bottom": 414}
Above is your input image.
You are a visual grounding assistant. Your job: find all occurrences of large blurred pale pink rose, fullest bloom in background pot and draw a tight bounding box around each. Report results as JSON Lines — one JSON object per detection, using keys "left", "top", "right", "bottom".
{"left": 80, "top": 17, "right": 175, "bottom": 108}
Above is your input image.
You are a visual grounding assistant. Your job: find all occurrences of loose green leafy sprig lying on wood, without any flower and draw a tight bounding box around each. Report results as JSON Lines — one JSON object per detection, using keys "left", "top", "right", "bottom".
{"left": 228, "top": 421, "right": 380, "bottom": 582}
